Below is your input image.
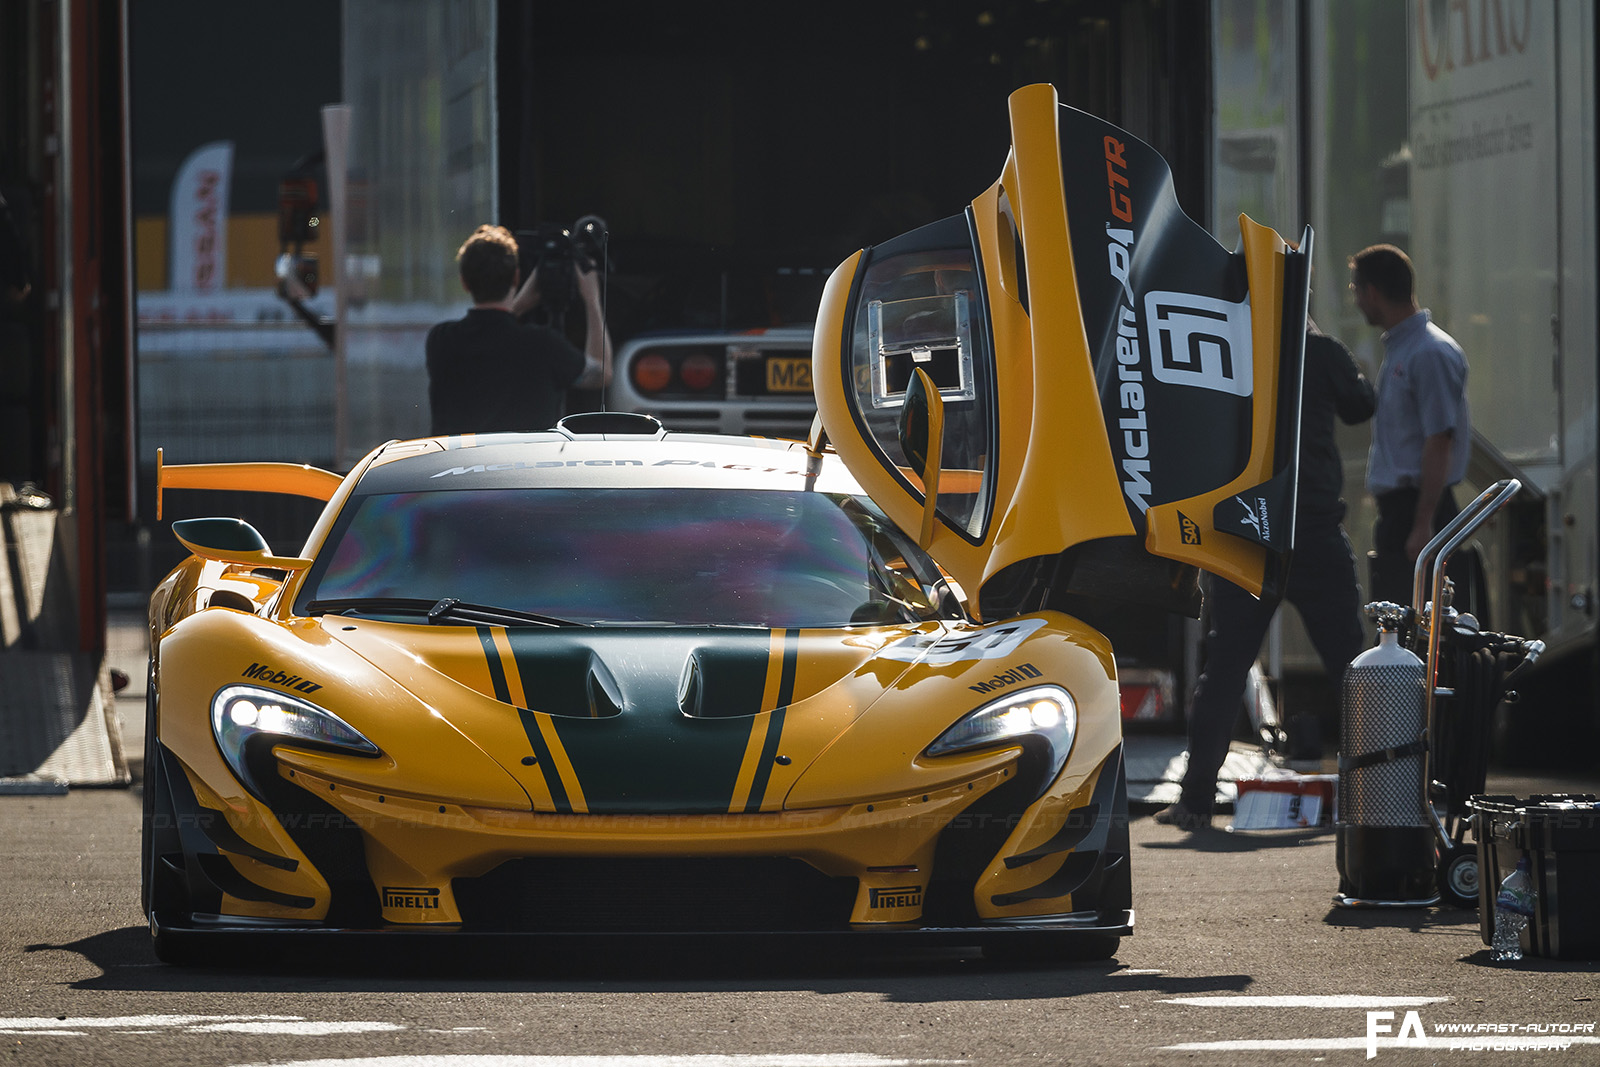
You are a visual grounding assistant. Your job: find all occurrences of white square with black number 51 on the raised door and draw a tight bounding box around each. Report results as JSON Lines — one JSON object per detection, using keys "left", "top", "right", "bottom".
{"left": 1144, "top": 293, "right": 1254, "bottom": 397}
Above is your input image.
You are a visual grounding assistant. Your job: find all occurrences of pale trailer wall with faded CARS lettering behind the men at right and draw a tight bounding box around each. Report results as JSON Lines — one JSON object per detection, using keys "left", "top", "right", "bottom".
{"left": 1213, "top": 0, "right": 1597, "bottom": 672}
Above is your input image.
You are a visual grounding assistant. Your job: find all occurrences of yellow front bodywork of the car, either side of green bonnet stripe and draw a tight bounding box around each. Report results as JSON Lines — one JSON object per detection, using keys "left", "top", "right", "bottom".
{"left": 152, "top": 531, "right": 1122, "bottom": 925}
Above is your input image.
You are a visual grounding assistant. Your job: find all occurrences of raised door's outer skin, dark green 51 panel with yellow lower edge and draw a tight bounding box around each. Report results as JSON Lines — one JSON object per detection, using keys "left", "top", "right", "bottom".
{"left": 1058, "top": 107, "right": 1312, "bottom": 609}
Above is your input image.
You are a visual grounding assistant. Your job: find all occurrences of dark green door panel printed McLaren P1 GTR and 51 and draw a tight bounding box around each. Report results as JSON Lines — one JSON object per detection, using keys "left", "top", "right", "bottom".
{"left": 1061, "top": 107, "right": 1254, "bottom": 530}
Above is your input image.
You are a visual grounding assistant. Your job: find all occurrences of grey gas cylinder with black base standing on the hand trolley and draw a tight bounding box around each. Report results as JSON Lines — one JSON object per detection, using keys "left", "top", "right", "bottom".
{"left": 1334, "top": 603, "right": 1438, "bottom": 907}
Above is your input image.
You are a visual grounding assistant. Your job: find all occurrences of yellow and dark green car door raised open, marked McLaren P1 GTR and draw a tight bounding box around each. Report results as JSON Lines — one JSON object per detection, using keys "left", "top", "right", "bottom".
{"left": 813, "top": 85, "right": 1310, "bottom": 617}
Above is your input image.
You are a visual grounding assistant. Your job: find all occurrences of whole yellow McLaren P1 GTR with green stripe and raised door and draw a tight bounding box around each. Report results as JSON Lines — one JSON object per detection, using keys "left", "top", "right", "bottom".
{"left": 142, "top": 86, "right": 1309, "bottom": 960}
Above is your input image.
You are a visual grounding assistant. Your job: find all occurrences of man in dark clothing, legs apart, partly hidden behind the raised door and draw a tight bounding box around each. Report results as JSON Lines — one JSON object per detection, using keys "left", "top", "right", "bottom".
{"left": 1155, "top": 322, "right": 1373, "bottom": 830}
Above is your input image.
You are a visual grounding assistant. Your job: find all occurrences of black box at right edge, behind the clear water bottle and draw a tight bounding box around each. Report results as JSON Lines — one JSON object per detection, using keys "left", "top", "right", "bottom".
{"left": 1467, "top": 793, "right": 1600, "bottom": 960}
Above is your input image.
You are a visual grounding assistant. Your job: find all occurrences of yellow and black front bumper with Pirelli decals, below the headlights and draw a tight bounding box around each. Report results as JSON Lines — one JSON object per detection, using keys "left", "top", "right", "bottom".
{"left": 152, "top": 747, "right": 1133, "bottom": 945}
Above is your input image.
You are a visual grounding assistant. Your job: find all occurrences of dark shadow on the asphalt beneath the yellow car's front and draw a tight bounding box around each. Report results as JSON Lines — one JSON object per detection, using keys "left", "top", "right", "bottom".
{"left": 26, "top": 926, "right": 1251, "bottom": 1003}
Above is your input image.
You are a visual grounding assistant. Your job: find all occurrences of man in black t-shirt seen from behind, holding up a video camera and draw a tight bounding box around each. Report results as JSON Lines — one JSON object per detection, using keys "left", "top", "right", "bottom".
{"left": 426, "top": 226, "right": 611, "bottom": 435}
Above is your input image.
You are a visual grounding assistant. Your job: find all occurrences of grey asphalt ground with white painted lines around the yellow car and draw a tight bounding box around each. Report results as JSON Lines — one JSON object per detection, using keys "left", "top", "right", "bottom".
{"left": 0, "top": 649, "right": 1600, "bottom": 1067}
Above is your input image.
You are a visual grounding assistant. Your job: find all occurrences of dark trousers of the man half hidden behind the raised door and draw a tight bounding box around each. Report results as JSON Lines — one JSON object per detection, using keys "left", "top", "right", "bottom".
{"left": 1182, "top": 518, "right": 1366, "bottom": 814}
